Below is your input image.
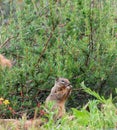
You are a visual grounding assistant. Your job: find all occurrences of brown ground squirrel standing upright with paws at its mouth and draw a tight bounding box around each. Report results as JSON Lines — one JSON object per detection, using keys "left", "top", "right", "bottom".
{"left": 46, "top": 78, "right": 72, "bottom": 119}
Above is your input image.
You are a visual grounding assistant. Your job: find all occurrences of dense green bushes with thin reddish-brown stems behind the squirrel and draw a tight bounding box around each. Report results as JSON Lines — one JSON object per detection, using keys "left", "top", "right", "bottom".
{"left": 0, "top": 0, "right": 117, "bottom": 118}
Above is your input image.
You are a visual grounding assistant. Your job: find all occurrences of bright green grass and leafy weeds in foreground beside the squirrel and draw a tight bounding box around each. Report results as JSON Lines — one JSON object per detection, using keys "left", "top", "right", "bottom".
{"left": 1, "top": 86, "right": 117, "bottom": 130}
